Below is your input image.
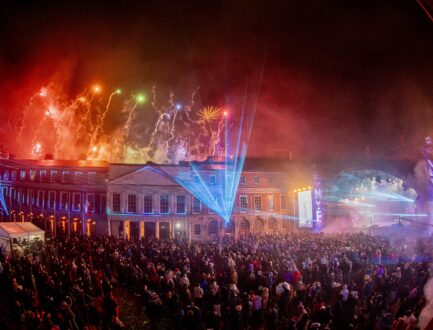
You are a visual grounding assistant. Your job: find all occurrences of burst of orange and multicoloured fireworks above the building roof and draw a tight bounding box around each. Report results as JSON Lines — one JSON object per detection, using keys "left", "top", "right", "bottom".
{"left": 15, "top": 84, "right": 228, "bottom": 163}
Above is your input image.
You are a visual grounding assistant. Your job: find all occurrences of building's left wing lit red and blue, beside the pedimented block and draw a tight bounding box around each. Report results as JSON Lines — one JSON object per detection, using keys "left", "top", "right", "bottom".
{"left": 0, "top": 159, "right": 108, "bottom": 235}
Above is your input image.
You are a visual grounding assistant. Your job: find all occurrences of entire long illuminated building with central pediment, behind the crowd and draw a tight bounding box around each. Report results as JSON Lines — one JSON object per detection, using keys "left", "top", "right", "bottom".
{"left": 0, "top": 159, "right": 312, "bottom": 240}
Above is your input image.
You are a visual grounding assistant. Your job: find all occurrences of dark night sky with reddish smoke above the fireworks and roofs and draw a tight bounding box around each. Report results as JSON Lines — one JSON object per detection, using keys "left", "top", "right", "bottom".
{"left": 0, "top": 0, "right": 433, "bottom": 158}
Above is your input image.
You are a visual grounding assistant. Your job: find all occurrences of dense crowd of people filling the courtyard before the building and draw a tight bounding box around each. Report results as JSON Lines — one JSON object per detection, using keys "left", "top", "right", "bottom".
{"left": 0, "top": 232, "right": 433, "bottom": 330}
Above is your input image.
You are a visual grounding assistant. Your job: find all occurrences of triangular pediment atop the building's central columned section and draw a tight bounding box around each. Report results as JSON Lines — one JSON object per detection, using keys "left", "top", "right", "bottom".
{"left": 110, "top": 165, "right": 178, "bottom": 186}
